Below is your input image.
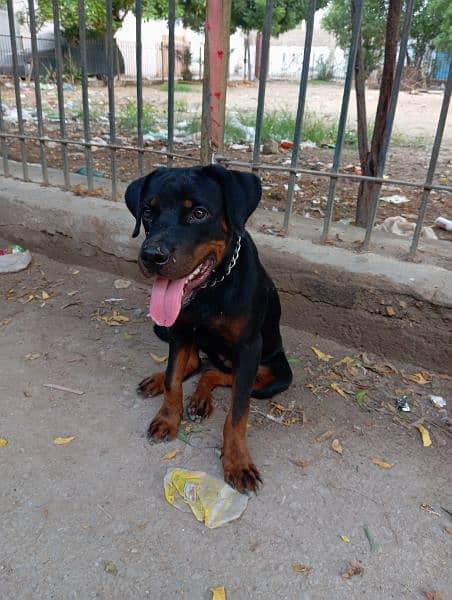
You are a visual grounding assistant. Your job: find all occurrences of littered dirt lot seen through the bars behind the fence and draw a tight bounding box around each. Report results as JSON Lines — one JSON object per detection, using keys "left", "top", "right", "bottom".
{"left": 2, "top": 81, "right": 452, "bottom": 229}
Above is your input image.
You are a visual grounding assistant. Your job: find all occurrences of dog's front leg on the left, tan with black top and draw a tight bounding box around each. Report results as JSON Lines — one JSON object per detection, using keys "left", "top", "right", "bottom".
{"left": 148, "top": 338, "right": 192, "bottom": 441}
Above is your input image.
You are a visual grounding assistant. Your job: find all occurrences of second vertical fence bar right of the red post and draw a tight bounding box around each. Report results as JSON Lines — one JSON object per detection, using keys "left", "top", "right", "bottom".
{"left": 284, "top": 0, "right": 316, "bottom": 231}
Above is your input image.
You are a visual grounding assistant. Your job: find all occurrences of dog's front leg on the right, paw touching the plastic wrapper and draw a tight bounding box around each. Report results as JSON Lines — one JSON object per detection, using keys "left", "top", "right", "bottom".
{"left": 223, "top": 336, "right": 262, "bottom": 492}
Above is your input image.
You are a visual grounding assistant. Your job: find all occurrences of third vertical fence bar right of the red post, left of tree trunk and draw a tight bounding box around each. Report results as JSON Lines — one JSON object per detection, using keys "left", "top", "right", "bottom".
{"left": 320, "top": 0, "right": 363, "bottom": 244}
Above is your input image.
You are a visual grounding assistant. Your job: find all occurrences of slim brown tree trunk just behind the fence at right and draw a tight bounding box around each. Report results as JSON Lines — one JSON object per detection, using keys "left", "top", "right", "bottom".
{"left": 356, "top": 0, "right": 402, "bottom": 227}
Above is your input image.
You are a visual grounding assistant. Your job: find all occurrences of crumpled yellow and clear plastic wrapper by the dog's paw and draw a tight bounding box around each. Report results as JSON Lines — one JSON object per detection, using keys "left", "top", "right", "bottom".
{"left": 164, "top": 469, "right": 248, "bottom": 529}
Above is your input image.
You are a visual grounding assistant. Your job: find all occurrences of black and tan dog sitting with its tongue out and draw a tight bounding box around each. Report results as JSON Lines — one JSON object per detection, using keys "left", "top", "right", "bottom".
{"left": 126, "top": 165, "right": 292, "bottom": 492}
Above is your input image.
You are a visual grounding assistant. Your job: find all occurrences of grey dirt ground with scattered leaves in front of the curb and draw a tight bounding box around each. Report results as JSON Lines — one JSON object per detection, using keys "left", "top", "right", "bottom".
{"left": 0, "top": 251, "right": 452, "bottom": 600}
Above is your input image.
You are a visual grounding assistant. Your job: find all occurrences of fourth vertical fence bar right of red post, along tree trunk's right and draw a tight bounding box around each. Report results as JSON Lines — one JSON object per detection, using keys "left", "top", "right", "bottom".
{"left": 362, "top": 0, "right": 414, "bottom": 250}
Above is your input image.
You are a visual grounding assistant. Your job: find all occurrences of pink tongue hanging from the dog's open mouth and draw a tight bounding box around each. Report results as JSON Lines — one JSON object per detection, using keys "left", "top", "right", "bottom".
{"left": 149, "top": 277, "right": 187, "bottom": 327}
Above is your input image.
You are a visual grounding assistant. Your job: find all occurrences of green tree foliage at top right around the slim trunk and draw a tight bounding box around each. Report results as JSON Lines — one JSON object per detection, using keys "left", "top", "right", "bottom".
{"left": 323, "top": 0, "right": 452, "bottom": 74}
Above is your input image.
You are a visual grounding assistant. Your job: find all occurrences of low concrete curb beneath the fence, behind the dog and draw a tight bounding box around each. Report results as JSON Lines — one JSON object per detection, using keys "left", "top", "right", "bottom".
{"left": 0, "top": 178, "right": 452, "bottom": 372}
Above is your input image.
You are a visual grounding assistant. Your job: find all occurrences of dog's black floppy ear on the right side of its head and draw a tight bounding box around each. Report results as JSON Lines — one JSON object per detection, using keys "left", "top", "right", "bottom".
{"left": 203, "top": 165, "right": 262, "bottom": 231}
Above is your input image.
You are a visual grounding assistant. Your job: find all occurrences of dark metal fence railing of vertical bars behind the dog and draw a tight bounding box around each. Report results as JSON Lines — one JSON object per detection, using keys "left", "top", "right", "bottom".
{"left": 0, "top": 0, "right": 452, "bottom": 258}
